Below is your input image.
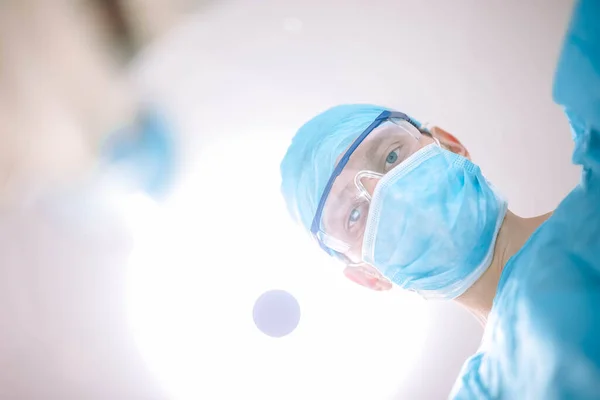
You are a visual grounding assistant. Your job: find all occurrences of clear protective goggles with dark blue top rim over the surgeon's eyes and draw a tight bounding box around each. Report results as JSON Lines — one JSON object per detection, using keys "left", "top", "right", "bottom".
{"left": 311, "top": 111, "right": 422, "bottom": 264}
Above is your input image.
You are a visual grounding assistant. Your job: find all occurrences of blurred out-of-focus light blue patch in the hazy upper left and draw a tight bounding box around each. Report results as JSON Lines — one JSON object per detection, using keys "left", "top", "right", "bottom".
{"left": 103, "top": 110, "right": 176, "bottom": 198}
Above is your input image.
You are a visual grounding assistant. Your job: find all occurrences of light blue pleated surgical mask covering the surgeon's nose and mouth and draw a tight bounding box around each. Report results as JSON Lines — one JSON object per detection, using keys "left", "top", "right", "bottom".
{"left": 362, "top": 144, "right": 507, "bottom": 299}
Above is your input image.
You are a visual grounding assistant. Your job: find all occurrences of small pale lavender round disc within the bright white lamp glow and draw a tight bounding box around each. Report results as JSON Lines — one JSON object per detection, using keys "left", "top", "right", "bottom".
{"left": 252, "top": 290, "right": 300, "bottom": 338}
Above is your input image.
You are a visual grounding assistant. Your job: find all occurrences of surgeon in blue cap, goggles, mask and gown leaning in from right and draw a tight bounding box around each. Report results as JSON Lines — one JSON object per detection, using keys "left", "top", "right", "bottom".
{"left": 281, "top": 0, "right": 600, "bottom": 399}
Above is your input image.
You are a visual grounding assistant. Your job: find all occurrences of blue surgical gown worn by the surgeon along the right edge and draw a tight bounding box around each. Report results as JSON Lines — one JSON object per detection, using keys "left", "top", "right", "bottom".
{"left": 451, "top": 0, "right": 600, "bottom": 399}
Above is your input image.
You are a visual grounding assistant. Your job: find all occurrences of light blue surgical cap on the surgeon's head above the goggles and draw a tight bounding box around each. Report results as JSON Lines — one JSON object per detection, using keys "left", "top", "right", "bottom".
{"left": 281, "top": 104, "right": 388, "bottom": 231}
